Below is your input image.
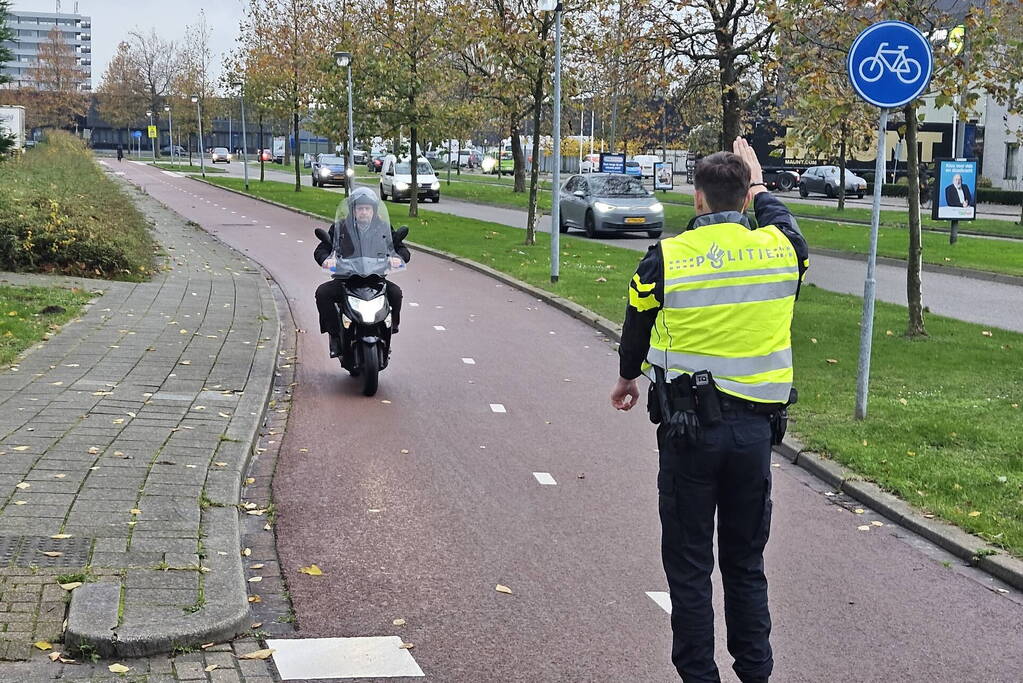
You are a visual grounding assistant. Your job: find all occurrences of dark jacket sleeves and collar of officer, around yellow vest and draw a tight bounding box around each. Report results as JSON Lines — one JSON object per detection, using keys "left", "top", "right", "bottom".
{"left": 618, "top": 192, "right": 809, "bottom": 379}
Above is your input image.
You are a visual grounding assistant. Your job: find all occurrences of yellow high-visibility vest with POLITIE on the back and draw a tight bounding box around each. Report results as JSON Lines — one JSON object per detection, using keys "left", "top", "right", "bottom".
{"left": 643, "top": 223, "right": 799, "bottom": 403}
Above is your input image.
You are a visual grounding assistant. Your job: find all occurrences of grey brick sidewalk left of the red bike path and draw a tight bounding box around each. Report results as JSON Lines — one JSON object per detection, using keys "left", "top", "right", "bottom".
{"left": 0, "top": 179, "right": 278, "bottom": 681}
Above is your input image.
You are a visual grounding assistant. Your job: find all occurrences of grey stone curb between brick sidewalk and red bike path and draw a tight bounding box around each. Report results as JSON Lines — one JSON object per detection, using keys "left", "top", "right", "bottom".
{"left": 64, "top": 169, "right": 280, "bottom": 657}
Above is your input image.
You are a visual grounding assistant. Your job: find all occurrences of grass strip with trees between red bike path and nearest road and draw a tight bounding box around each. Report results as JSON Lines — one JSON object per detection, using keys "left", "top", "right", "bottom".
{"left": 197, "top": 178, "right": 1023, "bottom": 556}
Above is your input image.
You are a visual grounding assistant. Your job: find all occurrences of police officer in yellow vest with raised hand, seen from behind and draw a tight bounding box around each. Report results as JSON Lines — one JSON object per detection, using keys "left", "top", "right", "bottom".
{"left": 611, "top": 138, "right": 808, "bottom": 683}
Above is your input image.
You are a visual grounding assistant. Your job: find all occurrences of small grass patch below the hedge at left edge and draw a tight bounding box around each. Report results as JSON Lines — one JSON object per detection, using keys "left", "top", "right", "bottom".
{"left": 0, "top": 286, "right": 91, "bottom": 367}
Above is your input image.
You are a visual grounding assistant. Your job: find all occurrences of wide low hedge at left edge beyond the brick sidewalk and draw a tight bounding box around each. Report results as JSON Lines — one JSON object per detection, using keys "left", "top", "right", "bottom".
{"left": 0, "top": 131, "right": 153, "bottom": 280}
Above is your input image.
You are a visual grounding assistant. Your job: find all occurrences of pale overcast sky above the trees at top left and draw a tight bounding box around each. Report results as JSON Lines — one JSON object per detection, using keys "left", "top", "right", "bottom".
{"left": 12, "top": 0, "right": 247, "bottom": 90}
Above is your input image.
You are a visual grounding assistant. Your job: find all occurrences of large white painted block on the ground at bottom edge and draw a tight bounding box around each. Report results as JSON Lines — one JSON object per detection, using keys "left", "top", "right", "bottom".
{"left": 266, "top": 636, "right": 425, "bottom": 681}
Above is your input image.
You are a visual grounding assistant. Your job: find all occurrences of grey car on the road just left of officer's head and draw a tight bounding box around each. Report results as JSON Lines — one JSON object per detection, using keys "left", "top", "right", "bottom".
{"left": 559, "top": 173, "right": 664, "bottom": 237}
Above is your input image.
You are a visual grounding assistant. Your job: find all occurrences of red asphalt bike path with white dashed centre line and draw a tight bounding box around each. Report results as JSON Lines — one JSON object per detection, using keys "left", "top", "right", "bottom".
{"left": 107, "top": 164, "right": 1023, "bottom": 683}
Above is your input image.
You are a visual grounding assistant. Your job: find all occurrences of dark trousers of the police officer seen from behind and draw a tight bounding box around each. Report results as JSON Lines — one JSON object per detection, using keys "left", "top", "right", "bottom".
{"left": 657, "top": 410, "right": 773, "bottom": 683}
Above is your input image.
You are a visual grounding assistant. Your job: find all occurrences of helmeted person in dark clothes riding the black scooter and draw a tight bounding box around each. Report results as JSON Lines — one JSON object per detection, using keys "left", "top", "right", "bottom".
{"left": 313, "top": 187, "right": 411, "bottom": 358}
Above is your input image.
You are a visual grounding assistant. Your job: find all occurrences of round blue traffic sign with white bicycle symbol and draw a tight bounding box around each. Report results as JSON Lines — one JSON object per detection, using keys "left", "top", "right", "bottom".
{"left": 846, "top": 21, "right": 934, "bottom": 108}
